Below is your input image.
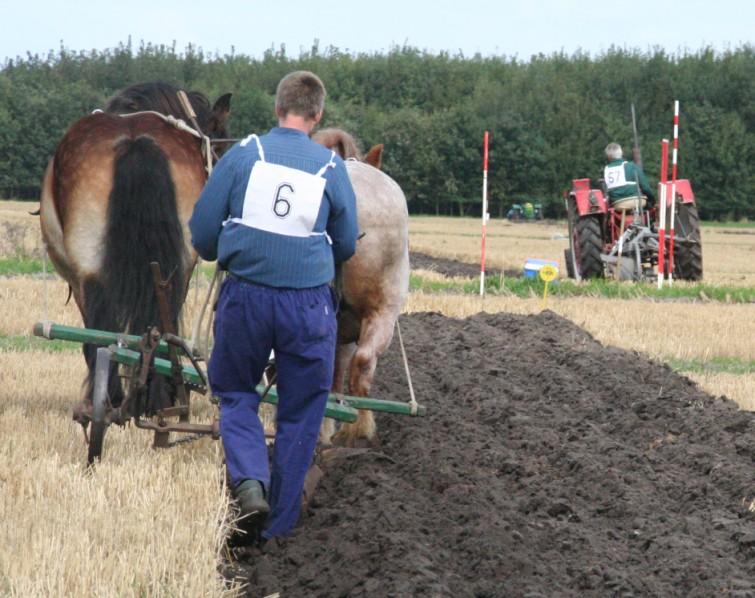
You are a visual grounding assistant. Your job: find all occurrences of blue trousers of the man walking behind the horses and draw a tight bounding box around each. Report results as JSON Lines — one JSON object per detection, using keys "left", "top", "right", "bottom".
{"left": 208, "top": 277, "right": 336, "bottom": 539}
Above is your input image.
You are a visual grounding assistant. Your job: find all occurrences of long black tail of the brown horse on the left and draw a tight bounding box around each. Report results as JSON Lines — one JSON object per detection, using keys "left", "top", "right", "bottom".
{"left": 84, "top": 136, "right": 185, "bottom": 405}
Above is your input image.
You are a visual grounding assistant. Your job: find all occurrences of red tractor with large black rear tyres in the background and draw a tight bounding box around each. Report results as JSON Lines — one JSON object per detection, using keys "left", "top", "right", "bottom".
{"left": 565, "top": 179, "right": 703, "bottom": 281}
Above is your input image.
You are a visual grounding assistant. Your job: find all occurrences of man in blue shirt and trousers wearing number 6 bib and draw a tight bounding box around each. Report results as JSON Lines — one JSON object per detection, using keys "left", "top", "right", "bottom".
{"left": 189, "top": 71, "right": 357, "bottom": 540}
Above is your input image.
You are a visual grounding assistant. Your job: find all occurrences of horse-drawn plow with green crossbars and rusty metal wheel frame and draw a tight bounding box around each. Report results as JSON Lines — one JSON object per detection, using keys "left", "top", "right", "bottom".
{"left": 33, "top": 263, "right": 425, "bottom": 465}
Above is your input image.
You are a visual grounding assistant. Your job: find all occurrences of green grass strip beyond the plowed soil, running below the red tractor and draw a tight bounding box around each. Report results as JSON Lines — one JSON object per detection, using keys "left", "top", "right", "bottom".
{"left": 409, "top": 274, "right": 755, "bottom": 303}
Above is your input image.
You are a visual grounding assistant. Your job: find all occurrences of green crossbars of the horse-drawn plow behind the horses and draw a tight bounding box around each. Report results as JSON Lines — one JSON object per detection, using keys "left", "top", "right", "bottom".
{"left": 33, "top": 322, "right": 426, "bottom": 422}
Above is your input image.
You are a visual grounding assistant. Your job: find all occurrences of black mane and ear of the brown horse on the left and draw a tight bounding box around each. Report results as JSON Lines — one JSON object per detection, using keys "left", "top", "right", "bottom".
{"left": 105, "top": 81, "right": 212, "bottom": 131}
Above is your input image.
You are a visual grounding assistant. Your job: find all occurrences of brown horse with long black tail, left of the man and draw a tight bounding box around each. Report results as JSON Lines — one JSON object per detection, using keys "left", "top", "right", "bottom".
{"left": 40, "top": 83, "right": 230, "bottom": 423}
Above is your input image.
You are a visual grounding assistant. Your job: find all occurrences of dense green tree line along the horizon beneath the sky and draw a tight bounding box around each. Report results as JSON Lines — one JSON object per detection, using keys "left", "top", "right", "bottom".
{"left": 0, "top": 42, "right": 755, "bottom": 219}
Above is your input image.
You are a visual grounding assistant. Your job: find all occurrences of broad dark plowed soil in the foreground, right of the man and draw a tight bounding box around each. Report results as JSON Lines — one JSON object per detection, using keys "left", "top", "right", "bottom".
{"left": 234, "top": 312, "right": 755, "bottom": 597}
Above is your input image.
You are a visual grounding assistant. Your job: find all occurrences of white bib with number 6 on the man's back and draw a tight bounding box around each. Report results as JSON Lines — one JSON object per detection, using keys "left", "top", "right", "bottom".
{"left": 231, "top": 135, "right": 335, "bottom": 237}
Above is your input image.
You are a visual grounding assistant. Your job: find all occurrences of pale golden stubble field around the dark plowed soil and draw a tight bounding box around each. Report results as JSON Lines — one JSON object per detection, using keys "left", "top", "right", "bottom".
{"left": 0, "top": 202, "right": 755, "bottom": 596}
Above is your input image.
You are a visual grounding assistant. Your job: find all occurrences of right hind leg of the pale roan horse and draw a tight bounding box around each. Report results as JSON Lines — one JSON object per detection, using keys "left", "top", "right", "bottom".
{"left": 333, "top": 312, "right": 396, "bottom": 447}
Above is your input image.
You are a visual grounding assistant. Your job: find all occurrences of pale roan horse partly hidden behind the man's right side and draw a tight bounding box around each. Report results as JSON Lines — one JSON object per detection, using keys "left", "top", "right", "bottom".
{"left": 312, "top": 129, "right": 409, "bottom": 446}
